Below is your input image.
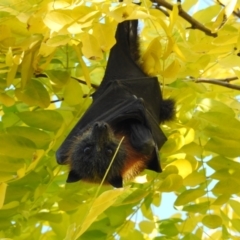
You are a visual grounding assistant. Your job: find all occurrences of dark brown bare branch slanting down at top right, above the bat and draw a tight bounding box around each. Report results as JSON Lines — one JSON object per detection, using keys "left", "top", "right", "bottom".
{"left": 151, "top": 0, "right": 217, "bottom": 37}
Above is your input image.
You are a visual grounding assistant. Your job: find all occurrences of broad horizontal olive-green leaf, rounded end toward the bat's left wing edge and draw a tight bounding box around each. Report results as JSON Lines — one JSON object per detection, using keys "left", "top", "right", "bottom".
{"left": 17, "top": 110, "right": 63, "bottom": 131}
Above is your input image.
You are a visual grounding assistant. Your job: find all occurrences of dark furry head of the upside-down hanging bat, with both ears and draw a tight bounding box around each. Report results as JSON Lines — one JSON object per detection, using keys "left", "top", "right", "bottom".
{"left": 67, "top": 122, "right": 125, "bottom": 187}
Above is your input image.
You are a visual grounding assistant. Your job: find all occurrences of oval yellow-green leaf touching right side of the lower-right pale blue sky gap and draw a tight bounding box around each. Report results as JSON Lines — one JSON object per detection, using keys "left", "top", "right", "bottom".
{"left": 174, "top": 189, "right": 206, "bottom": 206}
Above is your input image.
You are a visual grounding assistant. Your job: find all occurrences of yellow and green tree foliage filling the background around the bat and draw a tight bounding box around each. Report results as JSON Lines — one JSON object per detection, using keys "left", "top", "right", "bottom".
{"left": 0, "top": 0, "right": 240, "bottom": 240}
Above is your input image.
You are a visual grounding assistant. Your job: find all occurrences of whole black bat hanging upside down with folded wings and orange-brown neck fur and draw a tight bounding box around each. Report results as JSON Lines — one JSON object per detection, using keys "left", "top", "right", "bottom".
{"left": 56, "top": 20, "right": 174, "bottom": 187}
